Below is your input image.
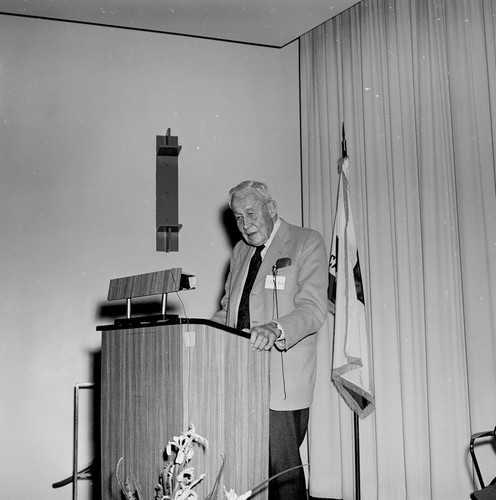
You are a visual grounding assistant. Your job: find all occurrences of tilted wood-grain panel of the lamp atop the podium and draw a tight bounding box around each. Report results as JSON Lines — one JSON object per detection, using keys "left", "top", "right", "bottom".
{"left": 107, "top": 267, "right": 182, "bottom": 300}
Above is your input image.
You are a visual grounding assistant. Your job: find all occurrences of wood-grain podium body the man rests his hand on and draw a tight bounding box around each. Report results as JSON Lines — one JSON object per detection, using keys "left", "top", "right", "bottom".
{"left": 98, "top": 317, "right": 269, "bottom": 500}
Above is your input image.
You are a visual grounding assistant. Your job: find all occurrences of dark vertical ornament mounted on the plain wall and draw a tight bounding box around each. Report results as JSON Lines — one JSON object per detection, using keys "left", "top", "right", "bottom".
{"left": 156, "top": 128, "right": 182, "bottom": 252}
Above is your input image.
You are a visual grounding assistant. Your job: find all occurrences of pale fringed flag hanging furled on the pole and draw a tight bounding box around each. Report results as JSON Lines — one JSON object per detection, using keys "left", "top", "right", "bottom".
{"left": 328, "top": 157, "right": 374, "bottom": 418}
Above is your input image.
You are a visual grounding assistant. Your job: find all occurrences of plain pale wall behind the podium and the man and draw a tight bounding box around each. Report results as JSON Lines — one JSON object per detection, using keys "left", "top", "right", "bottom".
{"left": 0, "top": 16, "right": 301, "bottom": 500}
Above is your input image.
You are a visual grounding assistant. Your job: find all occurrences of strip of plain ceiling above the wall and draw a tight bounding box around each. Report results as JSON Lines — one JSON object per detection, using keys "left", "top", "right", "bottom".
{"left": 0, "top": 0, "right": 359, "bottom": 47}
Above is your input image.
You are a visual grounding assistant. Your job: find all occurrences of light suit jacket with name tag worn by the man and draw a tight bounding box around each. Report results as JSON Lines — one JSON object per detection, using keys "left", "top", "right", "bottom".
{"left": 212, "top": 220, "right": 328, "bottom": 410}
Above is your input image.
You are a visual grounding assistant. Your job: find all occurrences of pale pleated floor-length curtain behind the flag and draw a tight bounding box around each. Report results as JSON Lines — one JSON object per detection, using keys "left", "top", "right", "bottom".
{"left": 299, "top": 0, "right": 496, "bottom": 500}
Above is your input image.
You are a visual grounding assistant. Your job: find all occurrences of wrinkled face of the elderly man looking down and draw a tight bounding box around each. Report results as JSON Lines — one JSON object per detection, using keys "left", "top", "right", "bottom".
{"left": 231, "top": 191, "right": 277, "bottom": 246}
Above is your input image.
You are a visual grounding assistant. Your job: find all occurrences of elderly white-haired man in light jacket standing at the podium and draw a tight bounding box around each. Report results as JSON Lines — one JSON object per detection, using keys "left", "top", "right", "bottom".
{"left": 212, "top": 181, "right": 328, "bottom": 500}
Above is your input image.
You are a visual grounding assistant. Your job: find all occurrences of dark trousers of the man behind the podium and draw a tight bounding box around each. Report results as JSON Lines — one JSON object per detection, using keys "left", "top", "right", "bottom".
{"left": 269, "top": 408, "right": 309, "bottom": 500}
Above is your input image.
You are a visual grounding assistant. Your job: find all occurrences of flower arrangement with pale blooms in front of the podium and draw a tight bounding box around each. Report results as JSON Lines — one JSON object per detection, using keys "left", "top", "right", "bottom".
{"left": 115, "top": 424, "right": 303, "bottom": 500}
